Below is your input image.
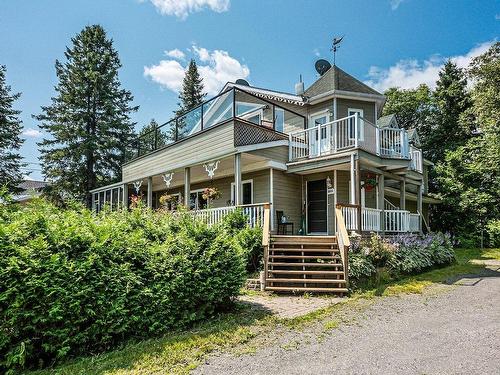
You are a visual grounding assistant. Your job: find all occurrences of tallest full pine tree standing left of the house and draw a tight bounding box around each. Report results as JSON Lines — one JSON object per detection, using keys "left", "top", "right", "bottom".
{"left": 34, "top": 25, "right": 138, "bottom": 206}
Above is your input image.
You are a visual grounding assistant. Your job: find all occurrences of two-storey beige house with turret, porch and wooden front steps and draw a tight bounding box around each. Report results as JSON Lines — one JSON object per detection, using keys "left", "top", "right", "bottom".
{"left": 92, "top": 66, "right": 438, "bottom": 292}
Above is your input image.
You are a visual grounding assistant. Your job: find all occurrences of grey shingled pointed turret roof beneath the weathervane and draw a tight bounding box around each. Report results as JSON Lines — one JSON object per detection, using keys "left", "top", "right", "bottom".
{"left": 304, "top": 65, "right": 383, "bottom": 97}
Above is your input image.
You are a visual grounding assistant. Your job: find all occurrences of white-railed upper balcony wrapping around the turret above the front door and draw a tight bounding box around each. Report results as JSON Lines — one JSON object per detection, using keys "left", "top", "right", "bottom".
{"left": 289, "top": 114, "right": 423, "bottom": 172}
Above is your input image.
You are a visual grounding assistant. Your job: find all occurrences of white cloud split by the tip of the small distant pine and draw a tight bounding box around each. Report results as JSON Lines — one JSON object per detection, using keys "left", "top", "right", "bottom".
{"left": 144, "top": 45, "right": 250, "bottom": 95}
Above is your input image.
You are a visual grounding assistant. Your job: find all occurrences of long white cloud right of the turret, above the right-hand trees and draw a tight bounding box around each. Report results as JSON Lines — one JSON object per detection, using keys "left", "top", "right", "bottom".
{"left": 365, "top": 41, "right": 493, "bottom": 92}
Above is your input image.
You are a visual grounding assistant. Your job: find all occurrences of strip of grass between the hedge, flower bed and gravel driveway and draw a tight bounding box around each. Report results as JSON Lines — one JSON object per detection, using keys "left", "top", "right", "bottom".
{"left": 29, "top": 249, "right": 500, "bottom": 375}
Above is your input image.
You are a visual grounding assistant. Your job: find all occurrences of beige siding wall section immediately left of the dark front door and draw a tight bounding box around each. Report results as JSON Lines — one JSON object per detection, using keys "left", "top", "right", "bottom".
{"left": 273, "top": 170, "right": 302, "bottom": 234}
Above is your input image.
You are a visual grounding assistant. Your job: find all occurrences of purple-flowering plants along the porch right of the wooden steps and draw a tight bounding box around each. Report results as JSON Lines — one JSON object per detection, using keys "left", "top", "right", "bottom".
{"left": 349, "top": 233, "right": 455, "bottom": 285}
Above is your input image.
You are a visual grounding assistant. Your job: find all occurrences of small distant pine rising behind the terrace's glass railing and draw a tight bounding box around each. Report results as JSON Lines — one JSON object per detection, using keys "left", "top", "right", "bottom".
{"left": 171, "top": 59, "right": 206, "bottom": 139}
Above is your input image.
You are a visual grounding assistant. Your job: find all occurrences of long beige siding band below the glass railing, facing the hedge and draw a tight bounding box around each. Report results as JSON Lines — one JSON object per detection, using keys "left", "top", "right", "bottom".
{"left": 122, "top": 122, "right": 235, "bottom": 181}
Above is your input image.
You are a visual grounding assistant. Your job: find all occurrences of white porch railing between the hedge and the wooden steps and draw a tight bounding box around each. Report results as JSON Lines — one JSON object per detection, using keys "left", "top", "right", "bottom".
{"left": 188, "top": 203, "right": 269, "bottom": 228}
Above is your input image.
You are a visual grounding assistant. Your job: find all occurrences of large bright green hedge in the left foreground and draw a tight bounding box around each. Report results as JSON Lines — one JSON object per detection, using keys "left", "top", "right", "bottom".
{"left": 0, "top": 201, "right": 245, "bottom": 372}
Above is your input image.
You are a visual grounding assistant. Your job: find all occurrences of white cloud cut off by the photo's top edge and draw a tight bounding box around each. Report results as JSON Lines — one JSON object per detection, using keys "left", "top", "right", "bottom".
{"left": 146, "top": 0, "right": 229, "bottom": 19}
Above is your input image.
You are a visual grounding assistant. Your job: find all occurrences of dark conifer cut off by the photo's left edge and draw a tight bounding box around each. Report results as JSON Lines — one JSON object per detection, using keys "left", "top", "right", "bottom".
{"left": 0, "top": 65, "right": 25, "bottom": 192}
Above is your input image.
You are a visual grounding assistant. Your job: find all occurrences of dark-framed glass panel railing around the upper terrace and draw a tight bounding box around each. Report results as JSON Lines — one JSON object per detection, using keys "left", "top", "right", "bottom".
{"left": 127, "top": 87, "right": 306, "bottom": 161}
